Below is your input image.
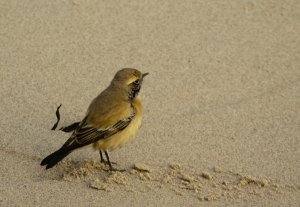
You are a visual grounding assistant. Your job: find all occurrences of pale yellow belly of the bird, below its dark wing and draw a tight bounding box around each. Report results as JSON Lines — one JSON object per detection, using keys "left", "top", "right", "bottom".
{"left": 93, "top": 108, "right": 142, "bottom": 151}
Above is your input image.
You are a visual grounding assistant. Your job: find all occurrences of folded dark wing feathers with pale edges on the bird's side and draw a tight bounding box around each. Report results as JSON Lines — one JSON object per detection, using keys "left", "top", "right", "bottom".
{"left": 64, "top": 109, "right": 135, "bottom": 150}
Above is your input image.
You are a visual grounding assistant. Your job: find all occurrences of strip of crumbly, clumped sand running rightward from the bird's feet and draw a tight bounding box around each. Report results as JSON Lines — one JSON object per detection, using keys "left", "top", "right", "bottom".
{"left": 57, "top": 160, "right": 282, "bottom": 202}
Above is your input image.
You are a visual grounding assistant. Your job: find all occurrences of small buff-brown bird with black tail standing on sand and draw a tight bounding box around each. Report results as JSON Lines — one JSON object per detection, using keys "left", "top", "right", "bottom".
{"left": 40, "top": 68, "right": 149, "bottom": 171}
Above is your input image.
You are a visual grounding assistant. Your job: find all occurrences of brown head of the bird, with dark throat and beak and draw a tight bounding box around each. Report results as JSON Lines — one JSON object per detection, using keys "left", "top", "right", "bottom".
{"left": 112, "top": 68, "right": 149, "bottom": 99}
